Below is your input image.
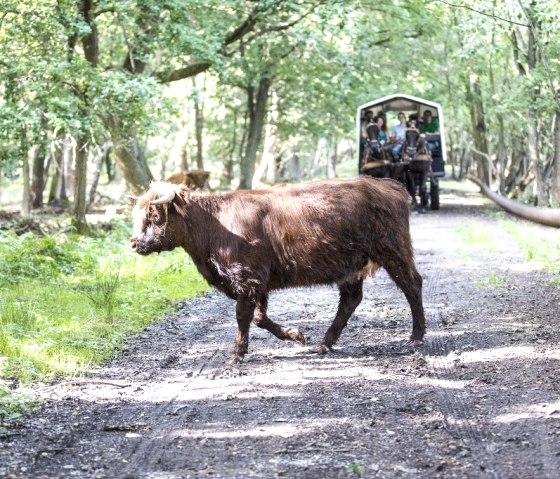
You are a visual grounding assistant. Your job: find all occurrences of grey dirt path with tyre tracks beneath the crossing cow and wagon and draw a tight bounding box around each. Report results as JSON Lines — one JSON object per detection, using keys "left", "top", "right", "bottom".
{"left": 0, "top": 188, "right": 560, "bottom": 479}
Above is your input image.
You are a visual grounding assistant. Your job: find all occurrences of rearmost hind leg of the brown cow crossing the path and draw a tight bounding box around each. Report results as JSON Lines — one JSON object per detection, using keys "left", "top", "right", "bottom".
{"left": 383, "top": 253, "right": 426, "bottom": 346}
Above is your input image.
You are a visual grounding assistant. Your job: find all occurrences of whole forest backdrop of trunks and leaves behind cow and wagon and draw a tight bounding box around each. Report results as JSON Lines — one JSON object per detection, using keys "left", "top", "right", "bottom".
{"left": 0, "top": 0, "right": 560, "bottom": 229}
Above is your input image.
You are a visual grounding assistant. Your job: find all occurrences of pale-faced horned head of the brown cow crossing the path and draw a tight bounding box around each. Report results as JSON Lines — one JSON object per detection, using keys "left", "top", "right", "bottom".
{"left": 130, "top": 181, "right": 185, "bottom": 255}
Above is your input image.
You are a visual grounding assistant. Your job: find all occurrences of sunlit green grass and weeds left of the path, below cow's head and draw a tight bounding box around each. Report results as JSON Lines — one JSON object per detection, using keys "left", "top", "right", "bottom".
{"left": 0, "top": 221, "right": 207, "bottom": 423}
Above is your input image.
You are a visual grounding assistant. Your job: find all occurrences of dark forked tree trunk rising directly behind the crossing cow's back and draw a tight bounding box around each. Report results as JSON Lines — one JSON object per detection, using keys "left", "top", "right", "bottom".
{"left": 239, "top": 77, "right": 271, "bottom": 189}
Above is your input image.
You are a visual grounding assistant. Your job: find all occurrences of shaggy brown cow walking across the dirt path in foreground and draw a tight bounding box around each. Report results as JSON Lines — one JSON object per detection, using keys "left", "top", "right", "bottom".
{"left": 130, "top": 177, "right": 425, "bottom": 363}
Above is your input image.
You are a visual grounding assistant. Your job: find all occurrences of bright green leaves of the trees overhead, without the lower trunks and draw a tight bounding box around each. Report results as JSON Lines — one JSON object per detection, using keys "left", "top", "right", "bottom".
{"left": 0, "top": 0, "right": 560, "bottom": 196}
